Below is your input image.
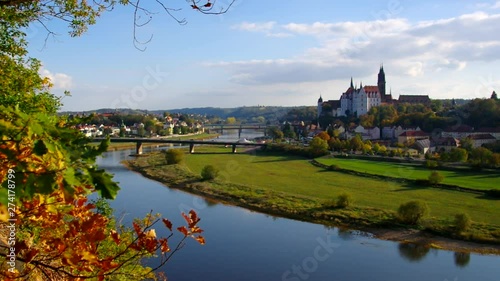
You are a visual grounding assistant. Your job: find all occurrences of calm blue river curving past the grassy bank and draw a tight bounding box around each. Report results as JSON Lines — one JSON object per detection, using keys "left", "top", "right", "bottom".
{"left": 98, "top": 130, "right": 500, "bottom": 281}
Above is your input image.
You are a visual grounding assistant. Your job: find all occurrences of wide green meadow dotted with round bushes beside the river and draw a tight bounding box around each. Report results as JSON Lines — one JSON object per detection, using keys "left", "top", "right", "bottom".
{"left": 128, "top": 146, "right": 500, "bottom": 247}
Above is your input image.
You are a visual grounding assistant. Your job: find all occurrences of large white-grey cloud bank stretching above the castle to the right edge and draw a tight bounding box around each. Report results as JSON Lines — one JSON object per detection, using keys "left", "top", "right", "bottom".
{"left": 217, "top": 11, "right": 500, "bottom": 85}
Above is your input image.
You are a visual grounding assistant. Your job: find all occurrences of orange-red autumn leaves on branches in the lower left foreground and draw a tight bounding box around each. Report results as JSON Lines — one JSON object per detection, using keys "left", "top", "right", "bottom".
{"left": 0, "top": 188, "right": 205, "bottom": 280}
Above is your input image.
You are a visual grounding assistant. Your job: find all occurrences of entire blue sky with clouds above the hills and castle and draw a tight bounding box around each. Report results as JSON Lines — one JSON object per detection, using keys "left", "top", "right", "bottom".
{"left": 27, "top": 0, "right": 500, "bottom": 111}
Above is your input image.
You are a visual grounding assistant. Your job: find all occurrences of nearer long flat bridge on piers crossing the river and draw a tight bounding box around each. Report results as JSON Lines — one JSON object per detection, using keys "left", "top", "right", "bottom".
{"left": 92, "top": 138, "right": 266, "bottom": 155}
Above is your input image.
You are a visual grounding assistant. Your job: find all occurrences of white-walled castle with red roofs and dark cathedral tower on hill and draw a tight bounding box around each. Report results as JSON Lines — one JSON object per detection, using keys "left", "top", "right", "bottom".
{"left": 318, "top": 65, "right": 392, "bottom": 117}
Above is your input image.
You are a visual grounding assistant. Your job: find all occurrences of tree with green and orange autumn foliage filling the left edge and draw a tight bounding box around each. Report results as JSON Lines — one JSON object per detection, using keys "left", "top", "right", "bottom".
{"left": 0, "top": 0, "right": 219, "bottom": 281}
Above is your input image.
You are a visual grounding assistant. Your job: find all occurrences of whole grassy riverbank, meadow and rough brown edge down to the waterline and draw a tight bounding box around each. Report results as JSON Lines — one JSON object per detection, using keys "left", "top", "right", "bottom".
{"left": 127, "top": 148, "right": 500, "bottom": 254}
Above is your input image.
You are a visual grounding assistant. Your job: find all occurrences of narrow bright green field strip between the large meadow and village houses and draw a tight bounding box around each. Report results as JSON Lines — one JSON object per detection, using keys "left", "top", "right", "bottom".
{"left": 316, "top": 157, "right": 500, "bottom": 190}
